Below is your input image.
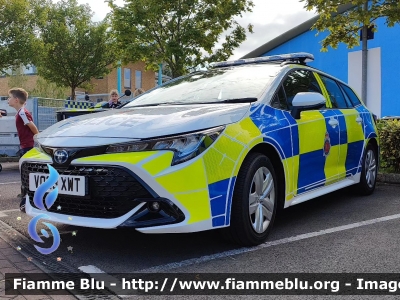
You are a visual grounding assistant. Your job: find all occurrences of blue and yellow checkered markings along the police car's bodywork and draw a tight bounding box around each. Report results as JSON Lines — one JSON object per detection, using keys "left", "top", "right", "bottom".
{"left": 25, "top": 97, "right": 377, "bottom": 229}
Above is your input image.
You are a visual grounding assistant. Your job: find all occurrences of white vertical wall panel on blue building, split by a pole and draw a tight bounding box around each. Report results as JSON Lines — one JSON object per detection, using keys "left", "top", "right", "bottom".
{"left": 348, "top": 47, "right": 382, "bottom": 117}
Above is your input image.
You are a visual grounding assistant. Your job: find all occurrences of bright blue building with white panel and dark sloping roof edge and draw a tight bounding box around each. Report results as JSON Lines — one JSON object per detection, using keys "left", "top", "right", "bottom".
{"left": 243, "top": 13, "right": 400, "bottom": 117}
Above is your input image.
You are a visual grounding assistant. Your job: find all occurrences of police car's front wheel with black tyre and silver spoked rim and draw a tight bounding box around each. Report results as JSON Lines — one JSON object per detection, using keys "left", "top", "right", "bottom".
{"left": 221, "top": 153, "right": 278, "bottom": 246}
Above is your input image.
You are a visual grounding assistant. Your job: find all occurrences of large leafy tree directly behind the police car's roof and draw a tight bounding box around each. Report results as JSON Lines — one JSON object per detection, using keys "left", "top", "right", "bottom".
{"left": 109, "top": 0, "right": 254, "bottom": 77}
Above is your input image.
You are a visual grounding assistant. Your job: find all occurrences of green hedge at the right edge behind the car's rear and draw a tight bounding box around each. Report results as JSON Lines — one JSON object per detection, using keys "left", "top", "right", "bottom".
{"left": 378, "top": 120, "right": 400, "bottom": 173}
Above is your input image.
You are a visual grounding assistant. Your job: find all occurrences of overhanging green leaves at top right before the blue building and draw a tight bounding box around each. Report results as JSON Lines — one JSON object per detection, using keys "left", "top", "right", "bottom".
{"left": 300, "top": 0, "right": 400, "bottom": 51}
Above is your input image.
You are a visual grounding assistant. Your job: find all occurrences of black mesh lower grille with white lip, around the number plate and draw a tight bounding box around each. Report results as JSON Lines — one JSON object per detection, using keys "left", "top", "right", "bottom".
{"left": 21, "top": 162, "right": 185, "bottom": 228}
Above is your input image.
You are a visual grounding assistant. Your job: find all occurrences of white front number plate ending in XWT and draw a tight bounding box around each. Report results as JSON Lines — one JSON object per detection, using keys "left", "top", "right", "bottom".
{"left": 29, "top": 173, "right": 85, "bottom": 196}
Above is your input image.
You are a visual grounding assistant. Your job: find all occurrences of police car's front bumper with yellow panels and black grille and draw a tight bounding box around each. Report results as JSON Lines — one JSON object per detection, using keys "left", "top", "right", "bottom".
{"left": 20, "top": 149, "right": 233, "bottom": 233}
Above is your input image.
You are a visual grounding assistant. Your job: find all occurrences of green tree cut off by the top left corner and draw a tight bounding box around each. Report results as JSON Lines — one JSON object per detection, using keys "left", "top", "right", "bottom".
{"left": 0, "top": 0, "right": 39, "bottom": 74}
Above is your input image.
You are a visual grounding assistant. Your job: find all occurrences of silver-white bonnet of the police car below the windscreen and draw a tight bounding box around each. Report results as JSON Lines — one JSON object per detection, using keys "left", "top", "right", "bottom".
{"left": 38, "top": 103, "right": 250, "bottom": 147}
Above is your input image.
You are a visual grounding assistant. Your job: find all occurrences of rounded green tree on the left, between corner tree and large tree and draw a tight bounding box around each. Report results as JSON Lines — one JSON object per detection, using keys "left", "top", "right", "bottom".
{"left": 36, "top": 0, "right": 117, "bottom": 99}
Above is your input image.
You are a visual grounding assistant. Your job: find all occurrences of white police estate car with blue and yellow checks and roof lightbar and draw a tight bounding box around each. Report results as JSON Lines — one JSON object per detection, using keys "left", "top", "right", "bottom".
{"left": 20, "top": 53, "right": 379, "bottom": 245}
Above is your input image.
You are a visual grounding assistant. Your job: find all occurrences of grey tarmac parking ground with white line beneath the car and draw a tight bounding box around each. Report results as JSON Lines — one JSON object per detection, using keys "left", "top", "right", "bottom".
{"left": 0, "top": 167, "right": 400, "bottom": 299}
